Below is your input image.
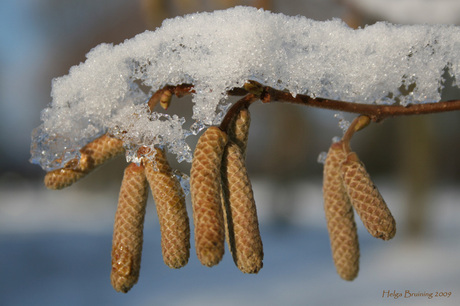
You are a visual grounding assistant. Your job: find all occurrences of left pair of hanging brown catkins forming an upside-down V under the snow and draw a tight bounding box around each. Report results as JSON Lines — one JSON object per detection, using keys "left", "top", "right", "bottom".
{"left": 111, "top": 148, "right": 190, "bottom": 292}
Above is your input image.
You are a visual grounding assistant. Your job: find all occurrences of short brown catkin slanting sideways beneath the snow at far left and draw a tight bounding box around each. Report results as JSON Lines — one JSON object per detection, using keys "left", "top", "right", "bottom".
{"left": 45, "top": 135, "right": 124, "bottom": 189}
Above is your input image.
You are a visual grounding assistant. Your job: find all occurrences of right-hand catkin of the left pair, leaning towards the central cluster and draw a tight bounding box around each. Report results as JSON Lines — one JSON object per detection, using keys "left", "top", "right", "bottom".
{"left": 144, "top": 148, "right": 190, "bottom": 269}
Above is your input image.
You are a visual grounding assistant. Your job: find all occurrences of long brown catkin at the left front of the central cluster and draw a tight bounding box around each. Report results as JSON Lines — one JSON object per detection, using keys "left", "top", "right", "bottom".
{"left": 190, "top": 126, "right": 228, "bottom": 267}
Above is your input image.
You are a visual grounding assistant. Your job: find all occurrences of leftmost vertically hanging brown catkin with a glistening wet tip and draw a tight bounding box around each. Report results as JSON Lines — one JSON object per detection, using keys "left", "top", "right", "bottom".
{"left": 110, "top": 163, "right": 148, "bottom": 293}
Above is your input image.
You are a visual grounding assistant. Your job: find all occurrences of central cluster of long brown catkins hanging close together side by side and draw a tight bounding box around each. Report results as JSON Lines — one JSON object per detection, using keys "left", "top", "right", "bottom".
{"left": 190, "top": 108, "right": 263, "bottom": 273}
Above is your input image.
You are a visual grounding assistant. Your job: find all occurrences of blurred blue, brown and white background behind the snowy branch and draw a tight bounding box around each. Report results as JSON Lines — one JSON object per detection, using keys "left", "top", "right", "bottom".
{"left": 0, "top": 0, "right": 460, "bottom": 305}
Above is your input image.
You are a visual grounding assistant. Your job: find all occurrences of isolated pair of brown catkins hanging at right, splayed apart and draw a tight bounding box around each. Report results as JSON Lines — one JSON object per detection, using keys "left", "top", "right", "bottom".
{"left": 323, "top": 141, "right": 396, "bottom": 280}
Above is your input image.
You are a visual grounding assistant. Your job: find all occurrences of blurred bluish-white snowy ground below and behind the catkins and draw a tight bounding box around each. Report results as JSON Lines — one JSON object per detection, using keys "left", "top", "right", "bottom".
{"left": 0, "top": 181, "right": 460, "bottom": 306}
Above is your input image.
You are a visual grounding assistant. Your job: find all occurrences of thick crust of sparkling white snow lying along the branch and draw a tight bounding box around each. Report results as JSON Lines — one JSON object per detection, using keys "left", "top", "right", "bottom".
{"left": 31, "top": 7, "right": 460, "bottom": 171}
